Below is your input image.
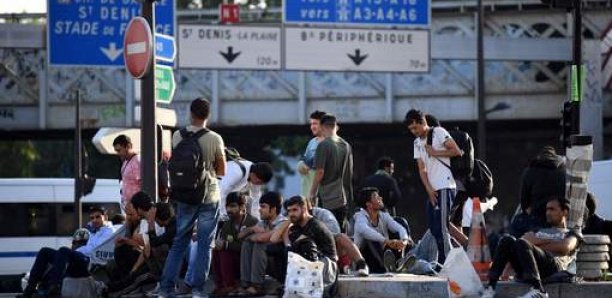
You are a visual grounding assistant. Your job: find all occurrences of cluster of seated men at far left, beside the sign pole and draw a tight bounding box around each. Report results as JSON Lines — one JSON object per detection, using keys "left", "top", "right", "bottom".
{"left": 18, "top": 192, "right": 176, "bottom": 297}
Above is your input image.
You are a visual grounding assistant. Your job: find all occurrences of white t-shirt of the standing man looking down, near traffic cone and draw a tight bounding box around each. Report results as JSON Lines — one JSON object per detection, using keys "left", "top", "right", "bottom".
{"left": 414, "top": 126, "right": 457, "bottom": 190}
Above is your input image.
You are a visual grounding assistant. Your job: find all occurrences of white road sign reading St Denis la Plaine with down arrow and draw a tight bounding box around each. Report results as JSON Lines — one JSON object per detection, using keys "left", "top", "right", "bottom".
{"left": 179, "top": 25, "right": 281, "bottom": 70}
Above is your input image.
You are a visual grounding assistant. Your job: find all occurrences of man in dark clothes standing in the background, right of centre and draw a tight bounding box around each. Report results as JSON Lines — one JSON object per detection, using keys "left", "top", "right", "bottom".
{"left": 363, "top": 156, "right": 402, "bottom": 216}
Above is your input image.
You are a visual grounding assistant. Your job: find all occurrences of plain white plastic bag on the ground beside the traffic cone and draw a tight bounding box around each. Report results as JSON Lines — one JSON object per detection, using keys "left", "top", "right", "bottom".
{"left": 439, "top": 247, "right": 483, "bottom": 297}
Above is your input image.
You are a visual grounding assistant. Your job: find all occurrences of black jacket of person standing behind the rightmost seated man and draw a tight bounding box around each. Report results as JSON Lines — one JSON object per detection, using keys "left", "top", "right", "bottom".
{"left": 521, "top": 154, "right": 565, "bottom": 223}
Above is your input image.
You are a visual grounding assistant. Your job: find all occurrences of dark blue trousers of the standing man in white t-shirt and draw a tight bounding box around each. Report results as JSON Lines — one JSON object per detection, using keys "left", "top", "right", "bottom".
{"left": 426, "top": 188, "right": 457, "bottom": 264}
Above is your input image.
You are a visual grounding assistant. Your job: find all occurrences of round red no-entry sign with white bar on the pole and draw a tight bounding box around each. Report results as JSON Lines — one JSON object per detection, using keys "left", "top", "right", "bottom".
{"left": 123, "top": 17, "right": 153, "bottom": 79}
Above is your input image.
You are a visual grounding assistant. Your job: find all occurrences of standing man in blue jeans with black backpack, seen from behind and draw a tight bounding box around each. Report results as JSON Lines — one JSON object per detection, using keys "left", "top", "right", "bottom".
{"left": 159, "top": 98, "right": 226, "bottom": 297}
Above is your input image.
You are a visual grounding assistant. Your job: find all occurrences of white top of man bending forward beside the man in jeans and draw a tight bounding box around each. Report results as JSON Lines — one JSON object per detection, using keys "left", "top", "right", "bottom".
{"left": 219, "top": 160, "right": 261, "bottom": 219}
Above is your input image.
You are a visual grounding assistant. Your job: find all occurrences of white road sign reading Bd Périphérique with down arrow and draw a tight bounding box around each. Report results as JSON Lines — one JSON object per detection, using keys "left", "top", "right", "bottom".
{"left": 284, "top": 28, "right": 430, "bottom": 72}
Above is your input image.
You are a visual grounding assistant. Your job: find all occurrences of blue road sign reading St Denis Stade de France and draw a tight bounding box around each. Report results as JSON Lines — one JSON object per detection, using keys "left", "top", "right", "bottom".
{"left": 47, "top": 0, "right": 175, "bottom": 67}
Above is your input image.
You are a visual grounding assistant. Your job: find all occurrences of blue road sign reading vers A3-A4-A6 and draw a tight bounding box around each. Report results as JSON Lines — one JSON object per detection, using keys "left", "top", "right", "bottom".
{"left": 283, "top": 0, "right": 431, "bottom": 28}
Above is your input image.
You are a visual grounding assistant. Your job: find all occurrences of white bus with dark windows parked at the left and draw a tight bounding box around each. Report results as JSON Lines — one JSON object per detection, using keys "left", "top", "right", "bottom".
{"left": 0, "top": 178, "right": 121, "bottom": 275}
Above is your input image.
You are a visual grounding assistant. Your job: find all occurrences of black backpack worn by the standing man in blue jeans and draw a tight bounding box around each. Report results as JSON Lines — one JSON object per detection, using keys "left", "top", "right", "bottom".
{"left": 168, "top": 128, "right": 209, "bottom": 205}
